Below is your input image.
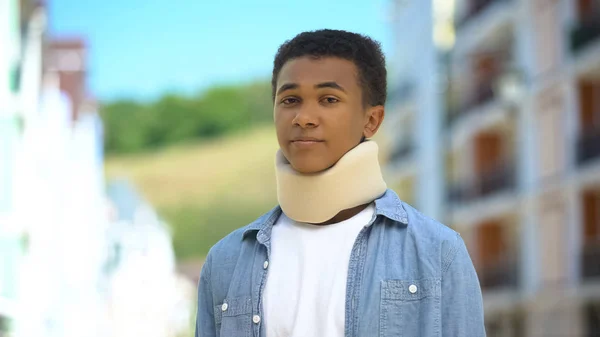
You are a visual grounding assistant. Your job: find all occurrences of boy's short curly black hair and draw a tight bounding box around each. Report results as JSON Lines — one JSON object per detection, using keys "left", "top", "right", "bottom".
{"left": 271, "top": 29, "right": 387, "bottom": 106}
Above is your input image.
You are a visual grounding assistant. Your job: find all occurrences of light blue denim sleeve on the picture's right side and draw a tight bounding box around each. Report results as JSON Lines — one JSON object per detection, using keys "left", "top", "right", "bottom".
{"left": 442, "top": 234, "right": 485, "bottom": 337}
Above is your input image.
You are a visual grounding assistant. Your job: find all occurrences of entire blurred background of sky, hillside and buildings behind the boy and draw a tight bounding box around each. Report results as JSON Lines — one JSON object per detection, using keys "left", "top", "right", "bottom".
{"left": 0, "top": 0, "right": 600, "bottom": 337}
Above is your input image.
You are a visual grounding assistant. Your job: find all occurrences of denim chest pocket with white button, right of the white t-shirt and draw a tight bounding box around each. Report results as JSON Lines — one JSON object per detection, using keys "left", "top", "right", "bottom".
{"left": 379, "top": 278, "right": 441, "bottom": 337}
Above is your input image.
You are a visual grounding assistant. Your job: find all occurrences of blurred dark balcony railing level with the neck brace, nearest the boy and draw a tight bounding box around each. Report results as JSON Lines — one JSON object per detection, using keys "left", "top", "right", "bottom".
{"left": 448, "top": 165, "right": 516, "bottom": 202}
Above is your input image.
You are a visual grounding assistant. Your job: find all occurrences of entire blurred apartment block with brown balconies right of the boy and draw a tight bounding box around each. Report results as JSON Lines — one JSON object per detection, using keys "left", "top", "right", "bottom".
{"left": 387, "top": 0, "right": 600, "bottom": 337}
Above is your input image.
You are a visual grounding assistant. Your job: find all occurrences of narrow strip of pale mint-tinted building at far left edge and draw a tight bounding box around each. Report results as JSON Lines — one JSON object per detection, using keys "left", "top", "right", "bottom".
{"left": 0, "top": 0, "right": 38, "bottom": 336}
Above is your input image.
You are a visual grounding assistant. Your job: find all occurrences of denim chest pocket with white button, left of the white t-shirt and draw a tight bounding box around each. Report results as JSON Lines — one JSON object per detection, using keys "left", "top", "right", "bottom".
{"left": 214, "top": 297, "right": 252, "bottom": 337}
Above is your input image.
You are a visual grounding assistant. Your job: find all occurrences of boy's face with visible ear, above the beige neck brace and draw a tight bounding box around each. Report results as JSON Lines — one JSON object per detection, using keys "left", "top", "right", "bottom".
{"left": 274, "top": 57, "right": 384, "bottom": 173}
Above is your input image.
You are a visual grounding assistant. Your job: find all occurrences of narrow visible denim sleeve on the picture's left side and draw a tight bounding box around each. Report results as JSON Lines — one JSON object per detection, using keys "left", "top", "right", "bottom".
{"left": 195, "top": 254, "right": 217, "bottom": 337}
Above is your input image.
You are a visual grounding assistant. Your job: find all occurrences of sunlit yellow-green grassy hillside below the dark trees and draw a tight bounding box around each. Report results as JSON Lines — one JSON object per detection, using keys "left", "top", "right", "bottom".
{"left": 106, "top": 125, "right": 278, "bottom": 260}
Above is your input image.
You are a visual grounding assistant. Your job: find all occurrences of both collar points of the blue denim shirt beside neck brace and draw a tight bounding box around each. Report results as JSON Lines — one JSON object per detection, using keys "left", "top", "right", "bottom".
{"left": 242, "top": 189, "right": 408, "bottom": 244}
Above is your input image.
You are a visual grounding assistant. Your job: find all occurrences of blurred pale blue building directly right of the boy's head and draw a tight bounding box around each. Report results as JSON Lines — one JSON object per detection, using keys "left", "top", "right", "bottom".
{"left": 383, "top": 1, "right": 451, "bottom": 218}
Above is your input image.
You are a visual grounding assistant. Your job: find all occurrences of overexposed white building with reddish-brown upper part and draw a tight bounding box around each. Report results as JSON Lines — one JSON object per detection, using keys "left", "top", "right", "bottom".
{"left": 12, "top": 2, "right": 107, "bottom": 336}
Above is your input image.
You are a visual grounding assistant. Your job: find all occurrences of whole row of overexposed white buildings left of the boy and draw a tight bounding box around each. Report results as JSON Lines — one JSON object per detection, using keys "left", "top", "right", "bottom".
{"left": 0, "top": 0, "right": 193, "bottom": 337}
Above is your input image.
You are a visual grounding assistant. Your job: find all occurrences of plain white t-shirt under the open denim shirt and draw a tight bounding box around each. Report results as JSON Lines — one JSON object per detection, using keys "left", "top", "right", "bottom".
{"left": 263, "top": 204, "right": 375, "bottom": 337}
